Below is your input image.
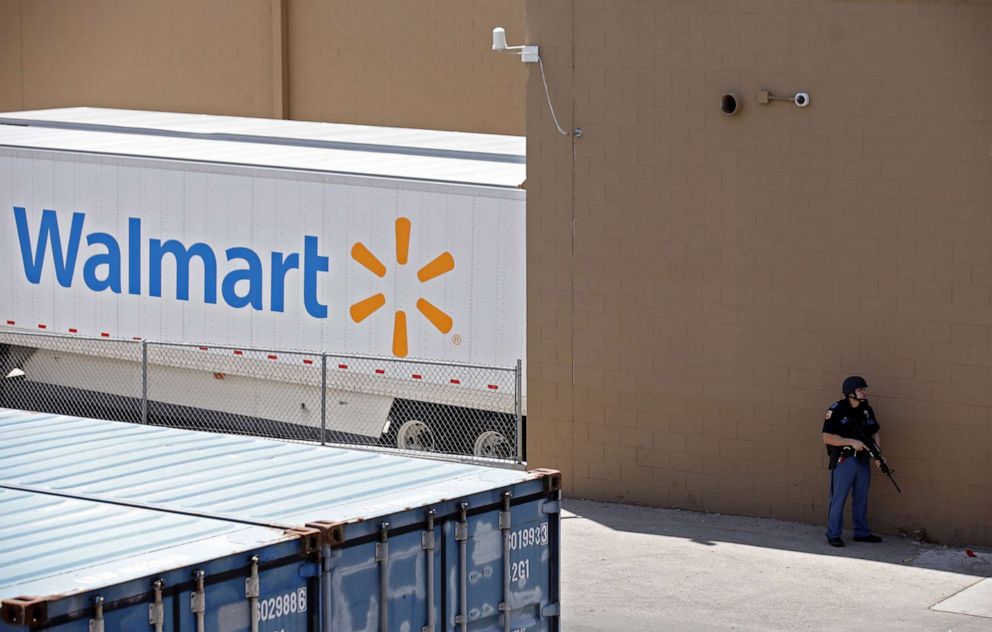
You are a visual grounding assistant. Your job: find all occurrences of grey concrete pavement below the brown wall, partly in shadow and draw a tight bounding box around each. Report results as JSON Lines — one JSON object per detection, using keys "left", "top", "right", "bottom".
{"left": 562, "top": 499, "right": 992, "bottom": 632}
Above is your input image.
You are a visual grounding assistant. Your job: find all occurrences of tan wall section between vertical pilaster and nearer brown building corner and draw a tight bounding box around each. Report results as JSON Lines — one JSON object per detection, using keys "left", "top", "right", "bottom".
{"left": 289, "top": 0, "right": 526, "bottom": 135}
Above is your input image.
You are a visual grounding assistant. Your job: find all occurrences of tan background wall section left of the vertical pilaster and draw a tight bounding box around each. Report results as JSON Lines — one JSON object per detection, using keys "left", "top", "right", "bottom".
{"left": 4, "top": 0, "right": 273, "bottom": 116}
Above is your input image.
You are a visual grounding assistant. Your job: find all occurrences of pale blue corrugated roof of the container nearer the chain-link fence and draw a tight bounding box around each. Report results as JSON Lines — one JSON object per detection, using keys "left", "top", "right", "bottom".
{"left": 0, "top": 409, "right": 539, "bottom": 525}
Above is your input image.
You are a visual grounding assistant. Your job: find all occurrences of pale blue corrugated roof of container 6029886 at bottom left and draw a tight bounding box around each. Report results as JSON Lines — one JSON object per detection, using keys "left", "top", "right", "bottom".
{"left": 0, "top": 487, "right": 296, "bottom": 600}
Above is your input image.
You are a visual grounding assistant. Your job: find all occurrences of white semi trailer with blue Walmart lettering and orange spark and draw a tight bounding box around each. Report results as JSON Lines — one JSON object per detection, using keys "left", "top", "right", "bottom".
{"left": 0, "top": 108, "right": 526, "bottom": 455}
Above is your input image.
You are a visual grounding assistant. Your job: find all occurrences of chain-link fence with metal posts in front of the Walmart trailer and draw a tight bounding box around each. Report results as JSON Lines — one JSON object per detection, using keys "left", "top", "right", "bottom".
{"left": 0, "top": 331, "right": 525, "bottom": 464}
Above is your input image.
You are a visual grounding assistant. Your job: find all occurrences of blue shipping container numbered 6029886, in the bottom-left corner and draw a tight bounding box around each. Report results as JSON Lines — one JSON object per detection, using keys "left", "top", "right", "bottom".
{"left": 0, "top": 486, "right": 319, "bottom": 632}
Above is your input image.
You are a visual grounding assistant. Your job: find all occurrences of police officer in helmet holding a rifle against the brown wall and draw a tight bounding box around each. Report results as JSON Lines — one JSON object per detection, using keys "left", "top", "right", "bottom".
{"left": 823, "top": 375, "right": 882, "bottom": 546}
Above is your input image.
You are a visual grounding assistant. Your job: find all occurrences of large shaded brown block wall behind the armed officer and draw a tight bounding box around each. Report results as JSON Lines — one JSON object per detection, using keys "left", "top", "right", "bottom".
{"left": 527, "top": 0, "right": 992, "bottom": 544}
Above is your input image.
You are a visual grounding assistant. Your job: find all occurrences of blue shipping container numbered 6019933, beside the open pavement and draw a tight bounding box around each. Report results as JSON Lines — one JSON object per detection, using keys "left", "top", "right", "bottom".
{"left": 0, "top": 410, "right": 560, "bottom": 631}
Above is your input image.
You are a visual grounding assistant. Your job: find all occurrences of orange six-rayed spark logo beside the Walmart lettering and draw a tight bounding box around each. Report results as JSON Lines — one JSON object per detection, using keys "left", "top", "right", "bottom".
{"left": 349, "top": 217, "right": 455, "bottom": 358}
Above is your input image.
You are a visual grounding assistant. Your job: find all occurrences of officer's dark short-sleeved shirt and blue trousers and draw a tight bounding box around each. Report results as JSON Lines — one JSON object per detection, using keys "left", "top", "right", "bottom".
{"left": 823, "top": 397, "right": 879, "bottom": 539}
